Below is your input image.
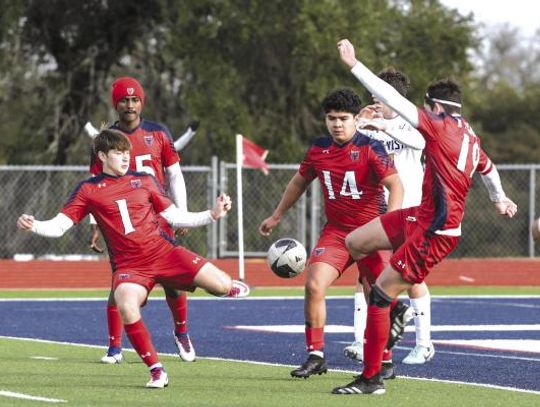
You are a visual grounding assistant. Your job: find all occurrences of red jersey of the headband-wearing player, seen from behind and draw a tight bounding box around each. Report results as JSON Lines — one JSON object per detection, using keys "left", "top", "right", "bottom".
{"left": 417, "top": 108, "right": 493, "bottom": 235}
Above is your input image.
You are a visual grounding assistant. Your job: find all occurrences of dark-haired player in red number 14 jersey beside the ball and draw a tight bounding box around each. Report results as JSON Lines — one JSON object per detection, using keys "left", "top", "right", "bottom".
{"left": 259, "top": 89, "right": 403, "bottom": 378}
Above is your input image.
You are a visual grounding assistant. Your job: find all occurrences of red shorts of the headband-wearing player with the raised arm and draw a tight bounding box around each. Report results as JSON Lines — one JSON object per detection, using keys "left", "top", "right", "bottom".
{"left": 380, "top": 207, "right": 459, "bottom": 284}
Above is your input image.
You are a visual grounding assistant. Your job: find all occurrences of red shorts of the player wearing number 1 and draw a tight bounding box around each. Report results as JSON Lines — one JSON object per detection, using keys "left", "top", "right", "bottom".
{"left": 112, "top": 246, "right": 208, "bottom": 292}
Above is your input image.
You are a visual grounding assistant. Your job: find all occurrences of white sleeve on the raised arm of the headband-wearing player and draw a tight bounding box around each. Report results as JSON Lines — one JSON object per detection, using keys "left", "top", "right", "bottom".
{"left": 351, "top": 61, "right": 419, "bottom": 128}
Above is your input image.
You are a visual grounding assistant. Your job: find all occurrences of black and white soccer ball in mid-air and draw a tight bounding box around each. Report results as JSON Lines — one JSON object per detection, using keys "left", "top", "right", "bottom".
{"left": 268, "top": 238, "right": 307, "bottom": 278}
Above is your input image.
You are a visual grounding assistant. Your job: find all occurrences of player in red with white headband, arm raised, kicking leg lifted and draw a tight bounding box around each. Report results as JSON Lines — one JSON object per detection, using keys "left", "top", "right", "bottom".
{"left": 332, "top": 39, "right": 517, "bottom": 394}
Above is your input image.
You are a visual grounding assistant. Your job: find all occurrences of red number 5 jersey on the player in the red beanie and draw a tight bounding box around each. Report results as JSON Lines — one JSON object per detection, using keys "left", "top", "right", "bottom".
{"left": 90, "top": 119, "right": 180, "bottom": 190}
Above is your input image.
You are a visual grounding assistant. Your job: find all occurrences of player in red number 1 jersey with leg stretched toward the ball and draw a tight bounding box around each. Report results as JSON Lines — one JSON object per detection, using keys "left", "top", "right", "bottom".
{"left": 17, "top": 130, "right": 249, "bottom": 388}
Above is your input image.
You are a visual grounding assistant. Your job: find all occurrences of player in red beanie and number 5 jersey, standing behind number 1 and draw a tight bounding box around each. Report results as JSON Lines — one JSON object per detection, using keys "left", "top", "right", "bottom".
{"left": 90, "top": 77, "right": 195, "bottom": 363}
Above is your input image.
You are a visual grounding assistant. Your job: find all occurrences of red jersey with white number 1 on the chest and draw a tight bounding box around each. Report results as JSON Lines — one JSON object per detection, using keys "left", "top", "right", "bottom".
{"left": 61, "top": 171, "right": 175, "bottom": 271}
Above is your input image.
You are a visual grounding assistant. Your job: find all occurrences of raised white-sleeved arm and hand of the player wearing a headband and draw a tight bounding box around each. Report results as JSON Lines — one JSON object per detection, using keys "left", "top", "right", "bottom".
{"left": 338, "top": 39, "right": 418, "bottom": 127}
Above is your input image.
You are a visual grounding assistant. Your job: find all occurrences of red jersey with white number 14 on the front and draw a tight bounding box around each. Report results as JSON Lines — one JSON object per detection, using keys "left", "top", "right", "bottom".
{"left": 298, "top": 132, "right": 397, "bottom": 231}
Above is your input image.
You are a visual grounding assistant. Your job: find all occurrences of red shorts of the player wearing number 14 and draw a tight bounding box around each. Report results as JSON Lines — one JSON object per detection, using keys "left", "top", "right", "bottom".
{"left": 308, "top": 224, "right": 354, "bottom": 276}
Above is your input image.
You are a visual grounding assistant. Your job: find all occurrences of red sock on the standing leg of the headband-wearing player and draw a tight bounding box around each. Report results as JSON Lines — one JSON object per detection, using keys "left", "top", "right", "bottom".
{"left": 362, "top": 305, "right": 390, "bottom": 378}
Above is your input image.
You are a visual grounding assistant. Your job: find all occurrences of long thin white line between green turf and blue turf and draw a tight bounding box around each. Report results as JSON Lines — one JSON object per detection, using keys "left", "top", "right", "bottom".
{"left": 0, "top": 335, "right": 540, "bottom": 395}
